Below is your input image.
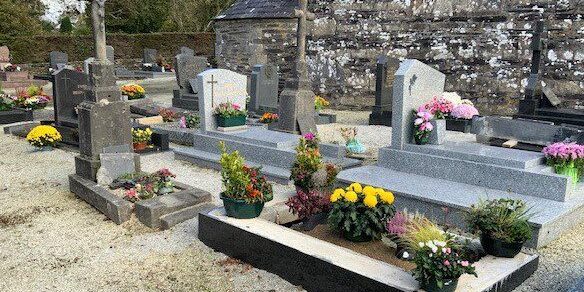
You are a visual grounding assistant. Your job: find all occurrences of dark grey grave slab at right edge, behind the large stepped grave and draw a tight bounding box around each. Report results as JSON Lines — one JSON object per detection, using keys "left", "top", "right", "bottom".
{"left": 472, "top": 116, "right": 584, "bottom": 146}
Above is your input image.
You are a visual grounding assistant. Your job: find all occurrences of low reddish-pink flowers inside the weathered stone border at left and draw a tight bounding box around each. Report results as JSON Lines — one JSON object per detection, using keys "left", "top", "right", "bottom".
{"left": 116, "top": 168, "right": 176, "bottom": 203}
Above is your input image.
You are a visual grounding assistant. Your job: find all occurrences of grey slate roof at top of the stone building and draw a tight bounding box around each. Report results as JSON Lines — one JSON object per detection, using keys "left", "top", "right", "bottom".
{"left": 215, "top": 0, "right": 298, "bottom": 21}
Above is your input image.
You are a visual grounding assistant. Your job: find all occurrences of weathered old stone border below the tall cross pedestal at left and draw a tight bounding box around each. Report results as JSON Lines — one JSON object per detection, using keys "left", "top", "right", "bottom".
{"left": 69, "top": 174, "right": 211, "bottom": 230}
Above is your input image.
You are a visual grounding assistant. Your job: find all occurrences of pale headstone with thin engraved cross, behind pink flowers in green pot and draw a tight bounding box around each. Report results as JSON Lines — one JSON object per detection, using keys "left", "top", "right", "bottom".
{"left": 196, "top": 69, "right": 247, "bottom": 131}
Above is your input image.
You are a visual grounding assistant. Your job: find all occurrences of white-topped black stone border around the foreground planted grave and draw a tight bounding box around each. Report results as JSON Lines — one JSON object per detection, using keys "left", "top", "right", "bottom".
{"left": 198, "top": 208, "right": 539, "bottom": 291}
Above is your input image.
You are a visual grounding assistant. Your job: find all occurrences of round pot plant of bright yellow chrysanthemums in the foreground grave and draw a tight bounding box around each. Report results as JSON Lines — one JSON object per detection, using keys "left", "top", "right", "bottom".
{"left": 328, "top": 183, "right": 395, "bottom": 242}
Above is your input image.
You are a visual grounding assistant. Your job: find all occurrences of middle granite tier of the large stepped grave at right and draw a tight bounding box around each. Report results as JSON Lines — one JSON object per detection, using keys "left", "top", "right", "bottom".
{"left": 377, "top": 148, "right": 574, "bottom": 201}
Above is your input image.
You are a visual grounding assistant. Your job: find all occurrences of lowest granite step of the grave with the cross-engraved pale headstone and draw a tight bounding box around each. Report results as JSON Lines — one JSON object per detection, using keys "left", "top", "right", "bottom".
{"left": 174, "top": 147, "right": 290, "bottom": 184}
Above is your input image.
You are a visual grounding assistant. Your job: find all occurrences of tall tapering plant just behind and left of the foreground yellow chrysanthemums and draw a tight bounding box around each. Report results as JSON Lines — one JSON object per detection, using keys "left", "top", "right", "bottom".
{"left": 290, "top": 133, "right": 339, "bottom": 193}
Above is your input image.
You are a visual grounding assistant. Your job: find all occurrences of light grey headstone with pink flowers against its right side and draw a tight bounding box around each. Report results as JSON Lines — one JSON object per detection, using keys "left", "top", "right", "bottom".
{"left": 391, "top": 59, "right": 446, "bottom": 150}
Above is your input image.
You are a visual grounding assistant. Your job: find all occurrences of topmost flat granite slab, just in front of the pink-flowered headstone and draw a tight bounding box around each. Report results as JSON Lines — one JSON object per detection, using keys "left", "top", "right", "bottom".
{"left": 404, "top": 141, "right": 544, "bottom": 169}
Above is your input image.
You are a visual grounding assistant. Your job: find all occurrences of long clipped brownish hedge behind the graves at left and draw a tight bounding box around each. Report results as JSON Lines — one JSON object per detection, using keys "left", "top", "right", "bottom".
{"left": 0, "top": 33, "right": 215, "bottom": 64}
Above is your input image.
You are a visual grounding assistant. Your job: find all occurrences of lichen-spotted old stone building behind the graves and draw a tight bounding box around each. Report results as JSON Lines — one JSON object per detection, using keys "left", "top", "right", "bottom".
{"left": 215, "top": 0, "right": 584, "bottom": 114}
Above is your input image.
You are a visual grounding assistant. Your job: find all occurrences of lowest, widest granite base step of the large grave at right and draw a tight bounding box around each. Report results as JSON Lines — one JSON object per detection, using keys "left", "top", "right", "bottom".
{"left": 338, "top": 166, "right": 584, "bottom": 248}
